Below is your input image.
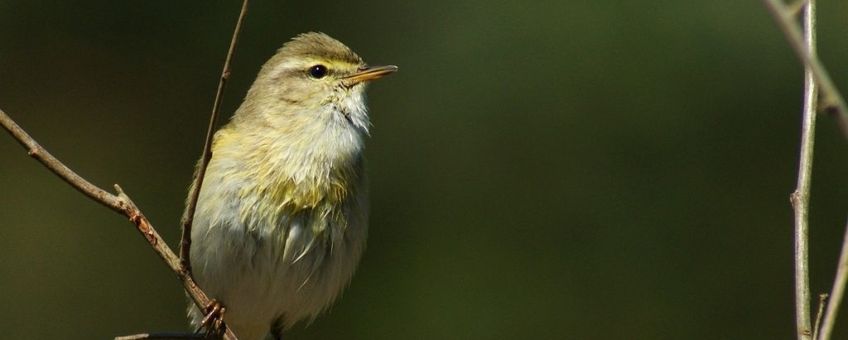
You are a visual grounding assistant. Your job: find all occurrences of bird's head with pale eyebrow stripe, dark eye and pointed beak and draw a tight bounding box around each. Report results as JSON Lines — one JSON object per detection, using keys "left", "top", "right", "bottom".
{"left": 236, "top": 32, "right": 397, "bottom": 133}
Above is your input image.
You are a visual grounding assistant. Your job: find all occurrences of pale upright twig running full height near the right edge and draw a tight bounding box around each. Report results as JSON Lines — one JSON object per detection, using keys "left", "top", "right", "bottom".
{"left": 790, "top": 0, "right": 818, "bottom": 340}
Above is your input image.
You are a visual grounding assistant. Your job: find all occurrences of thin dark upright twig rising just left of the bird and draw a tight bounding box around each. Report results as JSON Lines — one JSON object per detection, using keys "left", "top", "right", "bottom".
{"left": 180, "top": 0, "right": 248, "bottom": 273}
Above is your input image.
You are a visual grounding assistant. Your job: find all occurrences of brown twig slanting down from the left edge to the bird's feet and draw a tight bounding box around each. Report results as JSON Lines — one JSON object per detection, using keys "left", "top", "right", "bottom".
{"left": 0, "top": 109, "right": 237, "bottom": 340}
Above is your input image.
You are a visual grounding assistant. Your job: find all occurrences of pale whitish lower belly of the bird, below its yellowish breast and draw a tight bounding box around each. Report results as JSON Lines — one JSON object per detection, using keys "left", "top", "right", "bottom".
{"left": 191, "top": 205, "right": 366, "bottom": 339}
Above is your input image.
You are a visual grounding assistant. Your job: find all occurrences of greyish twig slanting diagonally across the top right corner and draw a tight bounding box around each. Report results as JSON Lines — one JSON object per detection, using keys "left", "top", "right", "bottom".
{"left": 763, "top": 0, "right": 848, "bottom": 138}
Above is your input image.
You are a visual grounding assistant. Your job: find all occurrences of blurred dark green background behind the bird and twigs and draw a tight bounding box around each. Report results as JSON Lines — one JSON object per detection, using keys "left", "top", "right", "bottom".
{"left": 0, "top": 0, "right": 848, "bottom": 339}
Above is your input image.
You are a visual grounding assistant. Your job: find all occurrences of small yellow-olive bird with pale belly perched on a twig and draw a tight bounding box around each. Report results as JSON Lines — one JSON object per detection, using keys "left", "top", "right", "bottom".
{"left": 189, "top": 32, "right": 397, "bottom": 340}
